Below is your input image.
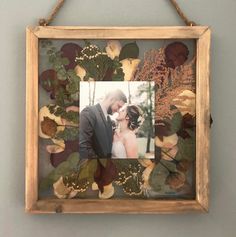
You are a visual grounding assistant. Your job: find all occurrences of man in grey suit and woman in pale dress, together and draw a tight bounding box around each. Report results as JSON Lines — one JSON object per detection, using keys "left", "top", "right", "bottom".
{"left": 79, "top": 90, "right": 142, "bottom": 159}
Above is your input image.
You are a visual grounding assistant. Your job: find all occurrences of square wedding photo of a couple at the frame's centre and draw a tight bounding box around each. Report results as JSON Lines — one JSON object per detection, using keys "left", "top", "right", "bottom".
{"left": 79, "top": 82, "right": 154, "bottom": 159}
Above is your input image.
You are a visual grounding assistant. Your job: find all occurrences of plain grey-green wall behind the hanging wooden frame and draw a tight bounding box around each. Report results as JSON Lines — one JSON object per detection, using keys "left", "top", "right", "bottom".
{"left": 0, "top": 0, "right": 236, "bottom": 237}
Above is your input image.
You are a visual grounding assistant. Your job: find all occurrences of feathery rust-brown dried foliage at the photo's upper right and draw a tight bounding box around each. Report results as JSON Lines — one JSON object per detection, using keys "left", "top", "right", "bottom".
{"left": 135, "top": 45, "right": 195, "bottom": 120}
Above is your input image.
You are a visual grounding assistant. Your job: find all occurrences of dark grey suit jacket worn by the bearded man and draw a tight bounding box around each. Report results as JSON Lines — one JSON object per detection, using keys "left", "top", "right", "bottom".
{"left": 79, "top": 104, "right": 112, "bottom": 159}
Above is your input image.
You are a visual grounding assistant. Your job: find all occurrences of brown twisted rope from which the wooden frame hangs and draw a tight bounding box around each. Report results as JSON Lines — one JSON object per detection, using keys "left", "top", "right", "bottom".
{"left": 39, "top": 0, "right": 196, "bottom": 26}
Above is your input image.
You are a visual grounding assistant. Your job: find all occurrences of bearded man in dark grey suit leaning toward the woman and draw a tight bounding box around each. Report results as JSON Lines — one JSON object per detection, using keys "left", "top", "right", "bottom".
{"left": 79, "top": 90, "right": 127, "bottom": 159}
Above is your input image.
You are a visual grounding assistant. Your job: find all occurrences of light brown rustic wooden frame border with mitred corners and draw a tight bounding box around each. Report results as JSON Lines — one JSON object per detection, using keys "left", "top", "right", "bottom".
{"left": 25, "top": 26, "right": 211, "bottom": 213}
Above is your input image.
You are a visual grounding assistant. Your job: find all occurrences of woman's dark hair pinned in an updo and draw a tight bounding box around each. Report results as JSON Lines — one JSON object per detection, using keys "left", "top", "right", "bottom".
{"left": 126, "top": 105, "right": 142, "bottom": 131}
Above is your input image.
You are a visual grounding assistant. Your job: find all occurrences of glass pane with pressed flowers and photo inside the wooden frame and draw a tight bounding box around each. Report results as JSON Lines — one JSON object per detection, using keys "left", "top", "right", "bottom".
{"left": 39, "top": 39, "right": 196, "bottom": 199}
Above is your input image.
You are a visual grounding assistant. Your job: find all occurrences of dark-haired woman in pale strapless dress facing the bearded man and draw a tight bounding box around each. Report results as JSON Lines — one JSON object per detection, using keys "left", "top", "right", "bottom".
{"left": 112, "top": 105, "right": 142, "bottom": 159}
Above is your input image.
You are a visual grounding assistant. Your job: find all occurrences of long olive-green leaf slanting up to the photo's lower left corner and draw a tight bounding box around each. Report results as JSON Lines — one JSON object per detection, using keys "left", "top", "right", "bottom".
{"left": 39, "top": 152, "right": 79, "bottom": 191}
